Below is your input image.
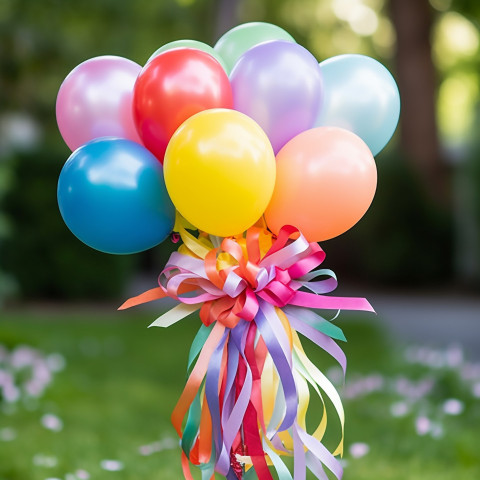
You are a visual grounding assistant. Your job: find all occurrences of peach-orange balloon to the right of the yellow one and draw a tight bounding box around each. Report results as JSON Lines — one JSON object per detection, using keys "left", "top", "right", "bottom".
{"left": 265, "top": 127, "right": 377, "bottom": 242}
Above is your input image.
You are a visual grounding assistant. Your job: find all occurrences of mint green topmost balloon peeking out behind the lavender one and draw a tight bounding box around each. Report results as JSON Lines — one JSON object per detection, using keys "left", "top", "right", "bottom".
{"left": 214, "top": 22, "right": 295, "bottom": 73}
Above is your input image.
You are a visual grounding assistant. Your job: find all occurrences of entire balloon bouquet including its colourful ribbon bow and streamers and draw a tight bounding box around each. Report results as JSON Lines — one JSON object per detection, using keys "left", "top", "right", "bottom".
{"left": 57, "top": 23, "right": 400, "bottom": 480}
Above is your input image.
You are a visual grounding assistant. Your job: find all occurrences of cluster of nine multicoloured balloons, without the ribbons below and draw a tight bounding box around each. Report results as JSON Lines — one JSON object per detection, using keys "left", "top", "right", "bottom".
{"left": 56, "top": 22, "right": 400, "bottom": 254}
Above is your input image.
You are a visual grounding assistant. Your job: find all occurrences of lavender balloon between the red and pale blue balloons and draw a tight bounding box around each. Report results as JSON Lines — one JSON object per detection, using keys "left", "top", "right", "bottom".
{"left": 230, "top": 41, "right": 322, "bottom": 153}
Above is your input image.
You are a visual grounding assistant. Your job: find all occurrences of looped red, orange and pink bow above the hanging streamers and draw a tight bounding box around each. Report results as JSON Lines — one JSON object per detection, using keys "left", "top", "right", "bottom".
{"left": 154, "top": 226, "right": 373, "bottom": 328}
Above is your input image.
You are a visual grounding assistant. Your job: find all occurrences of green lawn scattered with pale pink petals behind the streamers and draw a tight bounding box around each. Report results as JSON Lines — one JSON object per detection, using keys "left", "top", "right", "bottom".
{"left": 0, "top": 305, "right": 480, "bottom": 480}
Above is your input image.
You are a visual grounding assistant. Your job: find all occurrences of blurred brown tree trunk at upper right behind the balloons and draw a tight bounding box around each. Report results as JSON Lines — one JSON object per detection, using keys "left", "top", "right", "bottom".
{"left": 389, "top": 0, "right": 450, "bottom": 205}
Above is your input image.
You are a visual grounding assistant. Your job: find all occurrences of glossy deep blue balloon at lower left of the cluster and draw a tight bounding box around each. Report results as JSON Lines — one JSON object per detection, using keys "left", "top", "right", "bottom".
{"left": 57, "top": 138, "right": 175, "bottom": 254}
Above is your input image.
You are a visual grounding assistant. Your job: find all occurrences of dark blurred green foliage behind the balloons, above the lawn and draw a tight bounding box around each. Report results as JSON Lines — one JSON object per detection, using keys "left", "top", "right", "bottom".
{"left": 0, "top": 0, "right": 480, "bottom": 299}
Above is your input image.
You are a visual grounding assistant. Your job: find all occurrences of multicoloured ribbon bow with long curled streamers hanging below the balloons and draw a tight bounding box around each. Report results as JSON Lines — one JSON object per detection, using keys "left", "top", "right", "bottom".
{"left": 120, "top": 222, "right": 373, "bottom": 480}
